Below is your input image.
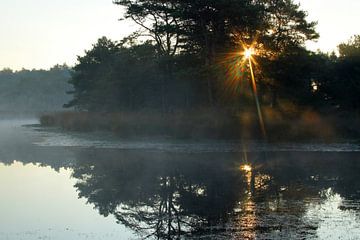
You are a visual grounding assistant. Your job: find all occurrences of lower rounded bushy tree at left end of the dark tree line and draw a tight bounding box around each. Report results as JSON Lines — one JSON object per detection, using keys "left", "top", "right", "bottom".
{"left": 65, "top": 38, "right": 178, "bottom": 112}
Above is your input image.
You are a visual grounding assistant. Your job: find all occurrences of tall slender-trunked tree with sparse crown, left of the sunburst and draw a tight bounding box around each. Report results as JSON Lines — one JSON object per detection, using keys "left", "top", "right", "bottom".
{"left": 114, "top": 0, "right": 188, "bottom": 112}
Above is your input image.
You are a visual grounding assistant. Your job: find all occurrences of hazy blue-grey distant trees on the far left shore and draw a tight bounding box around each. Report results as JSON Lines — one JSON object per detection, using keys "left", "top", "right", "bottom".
{"left": 0, "top": 65, "right": 72, "bottom": 113}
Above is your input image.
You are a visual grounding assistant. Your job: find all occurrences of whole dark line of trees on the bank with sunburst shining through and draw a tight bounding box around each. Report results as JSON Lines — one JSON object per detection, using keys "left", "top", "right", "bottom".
{"left": 65, "top": 0, "right": 360, "bottom": 112}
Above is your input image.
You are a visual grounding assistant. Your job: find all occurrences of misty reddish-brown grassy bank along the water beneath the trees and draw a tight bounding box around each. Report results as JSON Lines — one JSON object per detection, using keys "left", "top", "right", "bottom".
{"left": 40, "top": 106, "right": 360, "bottom": 141}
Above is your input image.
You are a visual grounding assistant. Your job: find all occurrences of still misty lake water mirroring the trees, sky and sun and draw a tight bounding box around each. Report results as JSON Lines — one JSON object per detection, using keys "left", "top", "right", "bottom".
{"left": 0, "top": 121, "right": 360, "bottom": 240}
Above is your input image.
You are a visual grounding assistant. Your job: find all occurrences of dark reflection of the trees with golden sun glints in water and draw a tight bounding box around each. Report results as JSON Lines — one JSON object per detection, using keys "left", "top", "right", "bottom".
{"left": 73, "top": 149, "right": 359, "bottom": 239}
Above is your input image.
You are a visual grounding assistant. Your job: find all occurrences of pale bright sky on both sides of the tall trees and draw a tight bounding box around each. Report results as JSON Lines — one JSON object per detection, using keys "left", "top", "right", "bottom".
{"left": 0, "top": 0, "right": 360, "bottom": 70}
